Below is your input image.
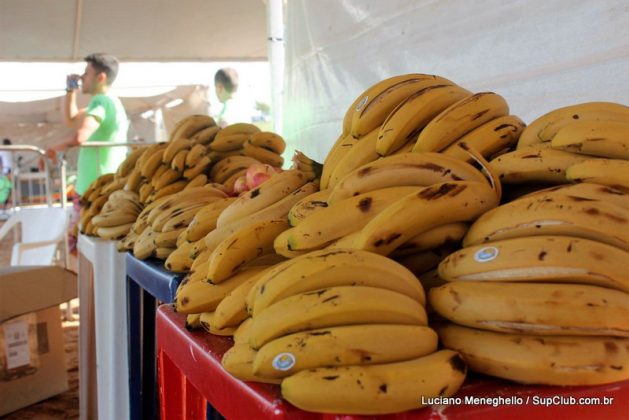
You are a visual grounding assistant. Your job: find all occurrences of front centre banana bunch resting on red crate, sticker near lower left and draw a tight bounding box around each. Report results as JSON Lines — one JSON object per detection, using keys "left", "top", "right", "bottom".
{"left": 213, "top": 249, "right": 466, "bottom": 414}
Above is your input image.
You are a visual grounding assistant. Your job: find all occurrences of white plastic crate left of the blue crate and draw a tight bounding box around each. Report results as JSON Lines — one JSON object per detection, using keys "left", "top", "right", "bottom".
{"left": 78, "top": 235, "right": 129, "bottom": 420}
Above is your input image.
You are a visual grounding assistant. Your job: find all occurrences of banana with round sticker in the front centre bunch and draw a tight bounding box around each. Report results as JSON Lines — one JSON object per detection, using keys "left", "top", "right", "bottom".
{"left": 253, "top": 324, "right": 437, "bottom": 379}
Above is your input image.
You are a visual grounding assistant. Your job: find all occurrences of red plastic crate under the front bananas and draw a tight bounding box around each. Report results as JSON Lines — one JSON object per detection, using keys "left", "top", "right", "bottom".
{"left": 156, "top": 305, "right": 629, "bottom": 420}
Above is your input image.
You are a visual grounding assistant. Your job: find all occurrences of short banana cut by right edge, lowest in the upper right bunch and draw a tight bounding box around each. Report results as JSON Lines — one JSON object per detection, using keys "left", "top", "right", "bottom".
{"left": 566, "top": 159, "right": 629, "bottom": 192}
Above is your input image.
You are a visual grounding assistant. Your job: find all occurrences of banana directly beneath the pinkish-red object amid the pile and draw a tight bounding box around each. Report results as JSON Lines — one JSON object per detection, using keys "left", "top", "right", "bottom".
{"left": 217, "top": 170, "right": 307, "bottom": 227}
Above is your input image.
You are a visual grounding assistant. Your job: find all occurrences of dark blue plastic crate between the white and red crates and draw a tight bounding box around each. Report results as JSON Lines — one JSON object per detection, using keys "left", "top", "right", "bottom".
{"left": 126, "top": 254, "right": 183, "bottom": 419}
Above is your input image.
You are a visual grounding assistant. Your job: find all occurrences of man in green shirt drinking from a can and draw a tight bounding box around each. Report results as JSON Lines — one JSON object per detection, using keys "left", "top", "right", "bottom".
{"left": 47, "top": 54, "right": 128, "bottom": 195}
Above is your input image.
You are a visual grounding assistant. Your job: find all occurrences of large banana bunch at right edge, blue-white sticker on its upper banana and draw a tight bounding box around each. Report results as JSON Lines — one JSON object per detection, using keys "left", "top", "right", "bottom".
{"left": 429, "top": 183, "right": 629, "bottom": 385}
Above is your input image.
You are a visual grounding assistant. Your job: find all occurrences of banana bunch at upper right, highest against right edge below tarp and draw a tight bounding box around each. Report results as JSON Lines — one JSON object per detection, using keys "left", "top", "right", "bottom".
{"left": 491, "top": 102, "right": 629, "bottom": 191}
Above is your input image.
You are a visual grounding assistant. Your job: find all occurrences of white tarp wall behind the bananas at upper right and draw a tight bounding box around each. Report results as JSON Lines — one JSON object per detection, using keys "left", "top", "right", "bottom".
{"left": 283, "top": 0, "right": 629, "bottom": 160}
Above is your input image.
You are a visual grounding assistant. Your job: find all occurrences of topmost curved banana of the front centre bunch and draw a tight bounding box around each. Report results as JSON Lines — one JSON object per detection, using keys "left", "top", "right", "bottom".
{"left": 251, "top": 249, "right": 426, "bottom": 316}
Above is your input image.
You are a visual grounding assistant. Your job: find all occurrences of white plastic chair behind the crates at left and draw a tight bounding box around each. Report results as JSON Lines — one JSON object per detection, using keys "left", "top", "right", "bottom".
{"left": 0, "top": 207, "right": 68, "bottom": 265}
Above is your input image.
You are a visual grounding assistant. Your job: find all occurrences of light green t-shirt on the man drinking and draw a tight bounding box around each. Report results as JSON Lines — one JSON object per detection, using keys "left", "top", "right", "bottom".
{"left": 76, "top": 94, "right": 129, "bottom": 195}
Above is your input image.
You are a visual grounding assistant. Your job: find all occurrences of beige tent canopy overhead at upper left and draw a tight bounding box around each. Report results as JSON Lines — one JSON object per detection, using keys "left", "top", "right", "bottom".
{"left": 0, "top": 0, "right": 267, "bottom": 62}
